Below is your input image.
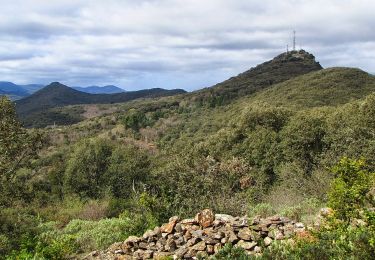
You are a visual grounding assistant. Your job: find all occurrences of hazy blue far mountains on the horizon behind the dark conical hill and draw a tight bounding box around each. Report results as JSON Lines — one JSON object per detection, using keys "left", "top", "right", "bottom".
{"left": 0, "top": 81, "right": 125, "bottom": 100}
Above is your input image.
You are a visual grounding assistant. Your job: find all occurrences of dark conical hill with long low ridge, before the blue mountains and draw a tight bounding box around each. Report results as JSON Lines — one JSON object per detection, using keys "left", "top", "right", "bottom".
{"left": 15, "top": 82, "right": 186, "bottom": 126}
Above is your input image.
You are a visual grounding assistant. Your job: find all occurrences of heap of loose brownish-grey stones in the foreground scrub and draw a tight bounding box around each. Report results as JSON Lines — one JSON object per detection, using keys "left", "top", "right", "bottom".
{"left": 84, "top": 209, "right": 318, "bottom": 260}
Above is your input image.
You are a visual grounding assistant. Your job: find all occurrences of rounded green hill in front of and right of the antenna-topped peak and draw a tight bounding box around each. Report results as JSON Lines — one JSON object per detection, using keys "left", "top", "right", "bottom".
{"left": 254, "top": 68, "right": 375, "bottom": 108}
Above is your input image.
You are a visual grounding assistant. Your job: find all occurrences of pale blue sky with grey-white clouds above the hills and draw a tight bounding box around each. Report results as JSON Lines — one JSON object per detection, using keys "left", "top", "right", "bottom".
{"left": 0, "top": 0, "right": 375, "bottom": 90}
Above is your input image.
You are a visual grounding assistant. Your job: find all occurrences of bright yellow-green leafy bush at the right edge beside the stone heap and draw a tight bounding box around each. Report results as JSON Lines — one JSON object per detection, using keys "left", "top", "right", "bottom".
{"left": 328, "top": 158, "right": 375, "bottom": 221}
